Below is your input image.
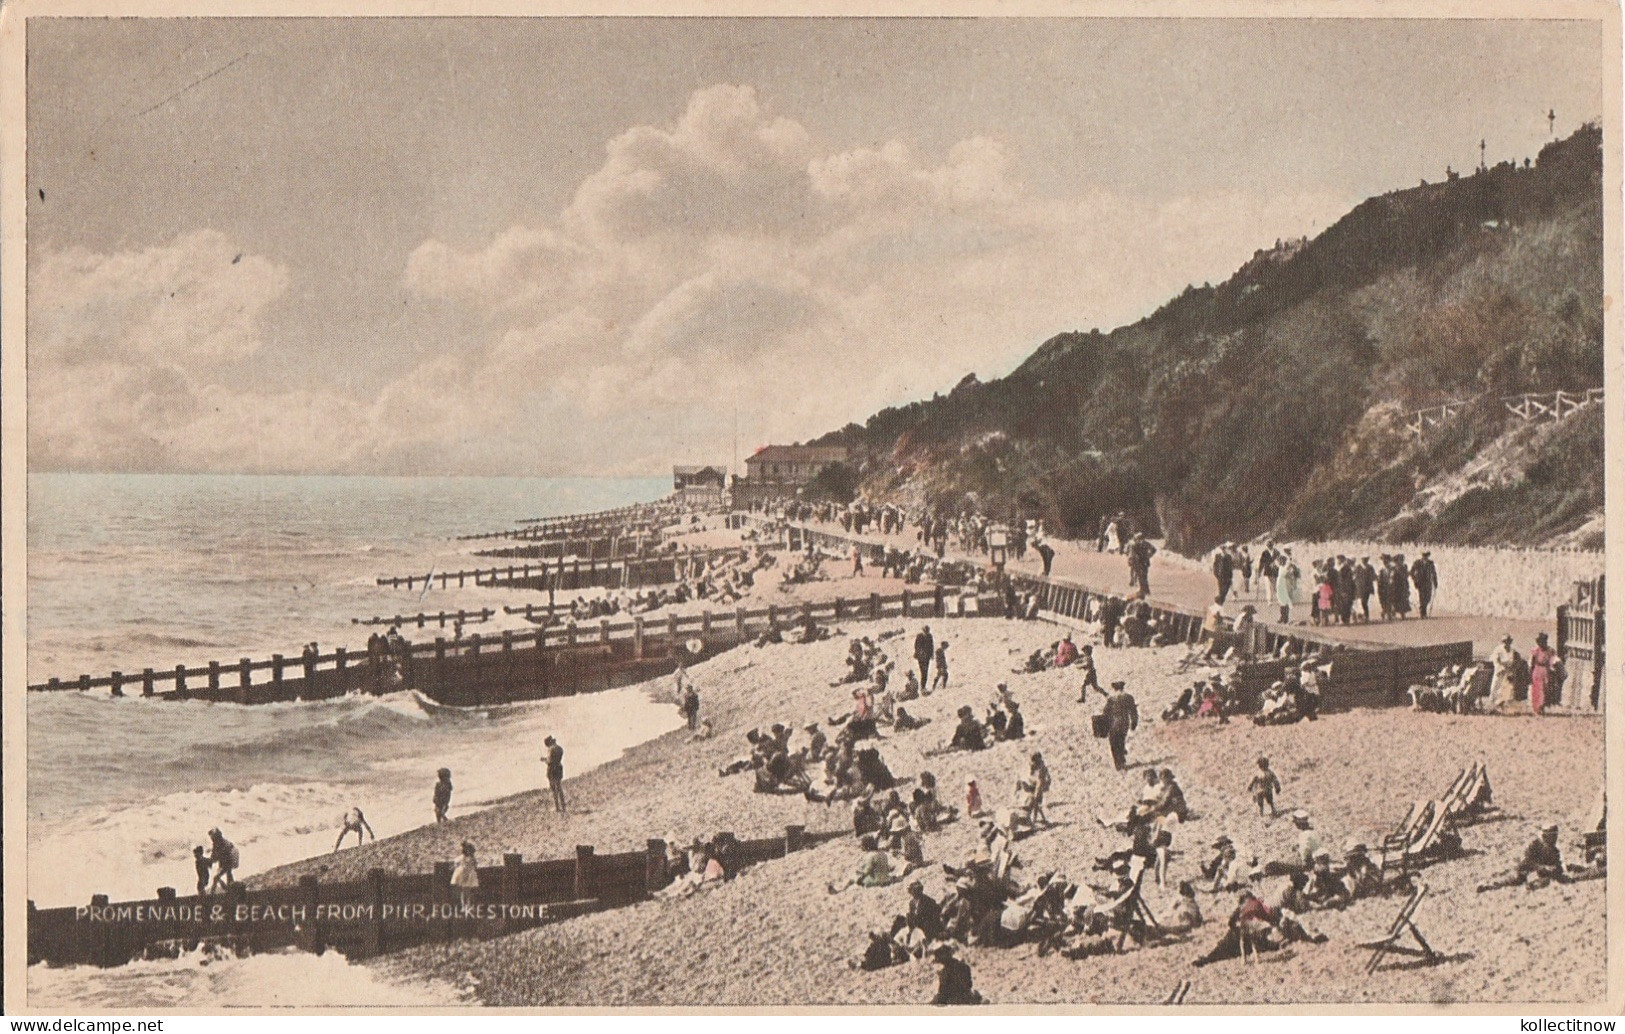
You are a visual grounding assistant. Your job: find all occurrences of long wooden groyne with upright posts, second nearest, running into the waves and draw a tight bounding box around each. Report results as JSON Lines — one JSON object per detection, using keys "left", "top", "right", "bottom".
{"left": 29, "top": 587, "right": 975, "bottom": 707}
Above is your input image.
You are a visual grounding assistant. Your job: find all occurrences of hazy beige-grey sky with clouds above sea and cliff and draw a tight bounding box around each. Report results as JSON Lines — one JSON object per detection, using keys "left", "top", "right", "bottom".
{"left": 28, "top": 18, "right": 1606, "bottom": 475}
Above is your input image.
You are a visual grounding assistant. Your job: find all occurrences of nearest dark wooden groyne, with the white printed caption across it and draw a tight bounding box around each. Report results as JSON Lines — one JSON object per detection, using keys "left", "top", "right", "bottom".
{"left": 28, "top": 826, "right": 845, "bottom": 966}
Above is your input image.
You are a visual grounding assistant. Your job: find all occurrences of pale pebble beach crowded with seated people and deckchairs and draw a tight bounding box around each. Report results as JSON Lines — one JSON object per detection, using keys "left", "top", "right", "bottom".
{"left": 252, "top": 601, "right": 1606, "bottom": 1006}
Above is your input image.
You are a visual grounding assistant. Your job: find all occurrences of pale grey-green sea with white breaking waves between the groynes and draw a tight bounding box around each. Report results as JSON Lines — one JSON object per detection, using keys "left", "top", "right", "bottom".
{"left": 26, "top": 473, "right": 681, "bottom": 1008}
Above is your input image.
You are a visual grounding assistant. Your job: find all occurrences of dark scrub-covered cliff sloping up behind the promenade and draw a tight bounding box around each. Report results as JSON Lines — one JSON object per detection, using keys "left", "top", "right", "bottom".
{"left": 816, "top": 127, "right": 1602, "bottom": 551}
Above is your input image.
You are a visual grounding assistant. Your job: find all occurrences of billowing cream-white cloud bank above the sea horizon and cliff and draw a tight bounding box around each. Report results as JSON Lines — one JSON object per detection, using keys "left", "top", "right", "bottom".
{"left": 29, "top": 86, "right": 1347, "bottom": 473}
